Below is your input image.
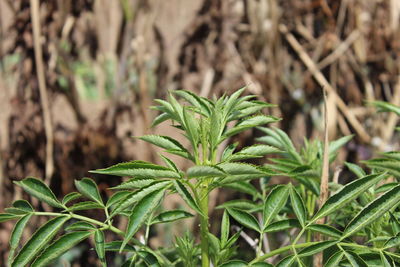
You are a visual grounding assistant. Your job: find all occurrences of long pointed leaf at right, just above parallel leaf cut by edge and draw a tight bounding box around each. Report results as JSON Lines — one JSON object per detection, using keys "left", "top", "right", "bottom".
{"left": 311, "top": 174, "right": 387, "bottom": 222}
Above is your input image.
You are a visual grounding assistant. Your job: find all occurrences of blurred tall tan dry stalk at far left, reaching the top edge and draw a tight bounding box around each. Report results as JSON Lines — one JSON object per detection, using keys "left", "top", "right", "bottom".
{"left": 30, "top": 0, "right": 54, "bottom": 184}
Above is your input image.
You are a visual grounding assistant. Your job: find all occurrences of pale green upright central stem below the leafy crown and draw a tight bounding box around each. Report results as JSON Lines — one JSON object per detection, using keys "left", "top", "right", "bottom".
{"left": 200, "top": 184, "right": 210, "bottom": 267}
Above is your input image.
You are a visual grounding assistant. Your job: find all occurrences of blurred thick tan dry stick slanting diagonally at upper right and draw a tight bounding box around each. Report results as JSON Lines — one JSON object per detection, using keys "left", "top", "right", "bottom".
{"left": 279, "top": 24, "right": 371, "bottom": 143}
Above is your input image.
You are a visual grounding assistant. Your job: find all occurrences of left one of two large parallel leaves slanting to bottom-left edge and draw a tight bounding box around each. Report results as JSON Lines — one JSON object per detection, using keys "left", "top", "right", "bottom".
{"left": 11, "top": 216, "right": 70, "bottom": 267}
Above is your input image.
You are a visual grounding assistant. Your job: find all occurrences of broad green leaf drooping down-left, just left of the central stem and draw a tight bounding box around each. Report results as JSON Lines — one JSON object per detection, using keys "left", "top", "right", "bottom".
{"left": 120, "top": 189, "right": 165, "bottom": 252}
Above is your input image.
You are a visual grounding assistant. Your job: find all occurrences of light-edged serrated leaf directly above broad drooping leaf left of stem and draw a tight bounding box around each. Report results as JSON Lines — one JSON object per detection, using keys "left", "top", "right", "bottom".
{"left": 110, "top": 181, "right": 171, "bottom": 218}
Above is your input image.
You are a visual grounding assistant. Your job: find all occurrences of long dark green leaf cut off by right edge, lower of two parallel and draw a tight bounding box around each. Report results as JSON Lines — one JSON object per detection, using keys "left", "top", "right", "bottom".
{"left": 342, "top": 185, "right": 400, "bottom": 239}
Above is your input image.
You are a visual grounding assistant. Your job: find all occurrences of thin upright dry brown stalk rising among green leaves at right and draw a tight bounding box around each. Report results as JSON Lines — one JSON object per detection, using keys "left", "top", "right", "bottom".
{"left": 314, "top": 88, "right": 329, "bottom": 267}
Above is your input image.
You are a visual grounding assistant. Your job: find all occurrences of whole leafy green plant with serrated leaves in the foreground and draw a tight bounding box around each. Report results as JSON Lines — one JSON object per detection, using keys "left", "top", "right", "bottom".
{"left": 0, "top": 89, "right": 400, "bottom": 267}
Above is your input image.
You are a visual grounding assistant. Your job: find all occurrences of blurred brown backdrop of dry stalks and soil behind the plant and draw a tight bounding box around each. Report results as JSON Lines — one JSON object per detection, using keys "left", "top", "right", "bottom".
{"left": 0, "top": 0, "right": 400, "bottom": 266}
